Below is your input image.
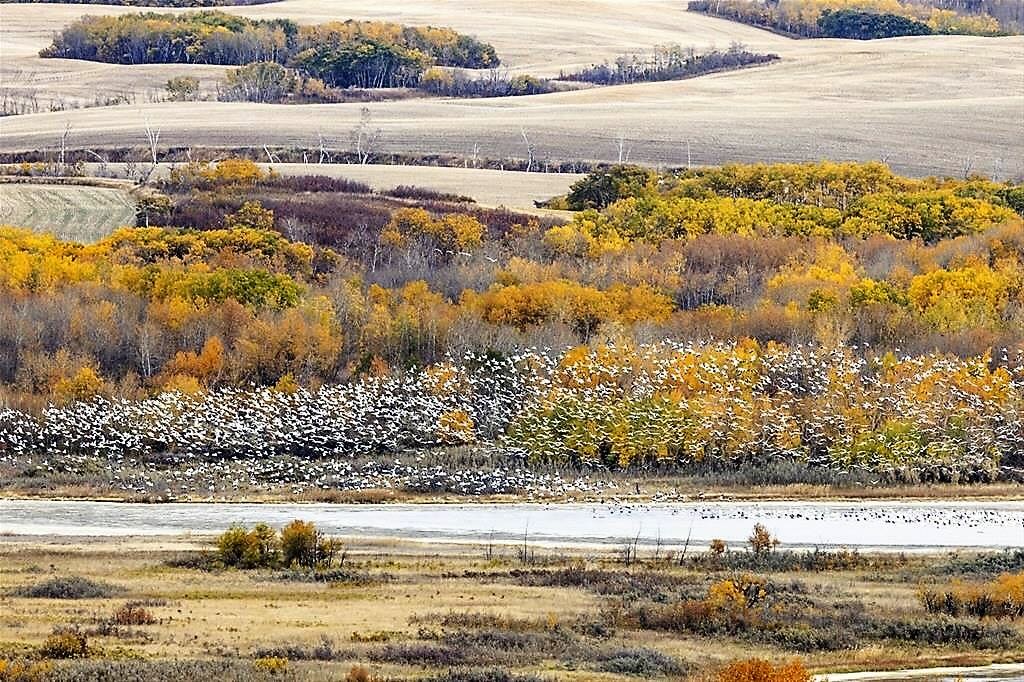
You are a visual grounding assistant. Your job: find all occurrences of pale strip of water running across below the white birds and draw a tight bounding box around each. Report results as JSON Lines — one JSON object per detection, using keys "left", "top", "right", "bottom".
{"left": 0, "top": 500, "right": 1024, "bottom": 551}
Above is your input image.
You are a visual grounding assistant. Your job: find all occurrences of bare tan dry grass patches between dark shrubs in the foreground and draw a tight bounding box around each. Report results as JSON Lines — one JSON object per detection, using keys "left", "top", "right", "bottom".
{"left": 0, "top": 538, "right": 1024, "bottom": 680}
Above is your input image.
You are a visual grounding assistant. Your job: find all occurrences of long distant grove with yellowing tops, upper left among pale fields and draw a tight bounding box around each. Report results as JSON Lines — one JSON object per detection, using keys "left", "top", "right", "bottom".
{"left": 40, "top": 11, "right": 500, "bottom": 87}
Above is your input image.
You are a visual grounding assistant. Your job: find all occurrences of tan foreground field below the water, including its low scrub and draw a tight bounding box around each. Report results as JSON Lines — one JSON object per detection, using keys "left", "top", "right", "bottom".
{"left": 0, "top": 538, "right": 1024, "bottom": 680}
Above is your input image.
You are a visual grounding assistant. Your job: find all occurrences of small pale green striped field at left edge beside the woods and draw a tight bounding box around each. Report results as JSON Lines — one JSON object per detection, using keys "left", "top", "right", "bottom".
{"left": 0, "top": 183, "right": 135, "bottom": 243}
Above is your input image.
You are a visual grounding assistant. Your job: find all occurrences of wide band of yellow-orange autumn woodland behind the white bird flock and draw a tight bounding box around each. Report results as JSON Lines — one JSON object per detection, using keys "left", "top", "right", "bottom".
{"left": 0, "top": 160, "right": 1024, "bottom": 407}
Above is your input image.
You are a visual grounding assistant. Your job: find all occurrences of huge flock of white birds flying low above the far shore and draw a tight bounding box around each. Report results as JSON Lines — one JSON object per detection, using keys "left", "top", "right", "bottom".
{"left": 0, "top": 342, "right": 1024, "bottom": 497}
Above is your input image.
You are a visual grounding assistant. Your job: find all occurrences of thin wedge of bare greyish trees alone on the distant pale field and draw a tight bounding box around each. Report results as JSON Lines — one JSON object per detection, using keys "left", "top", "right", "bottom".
{"left": 559, "top": 44, "right": 778, "bottom": 85}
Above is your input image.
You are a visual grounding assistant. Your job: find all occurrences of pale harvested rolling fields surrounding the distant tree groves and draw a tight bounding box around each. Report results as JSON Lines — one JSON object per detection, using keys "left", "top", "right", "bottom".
{"left": 0, "top": 0, "right": 1024, "bottom": 176}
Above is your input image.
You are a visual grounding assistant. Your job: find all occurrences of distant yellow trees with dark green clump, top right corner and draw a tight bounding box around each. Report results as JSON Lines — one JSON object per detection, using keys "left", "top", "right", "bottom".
{"left": 688, "top": 0, "right": 1022, "bottom": 40}
